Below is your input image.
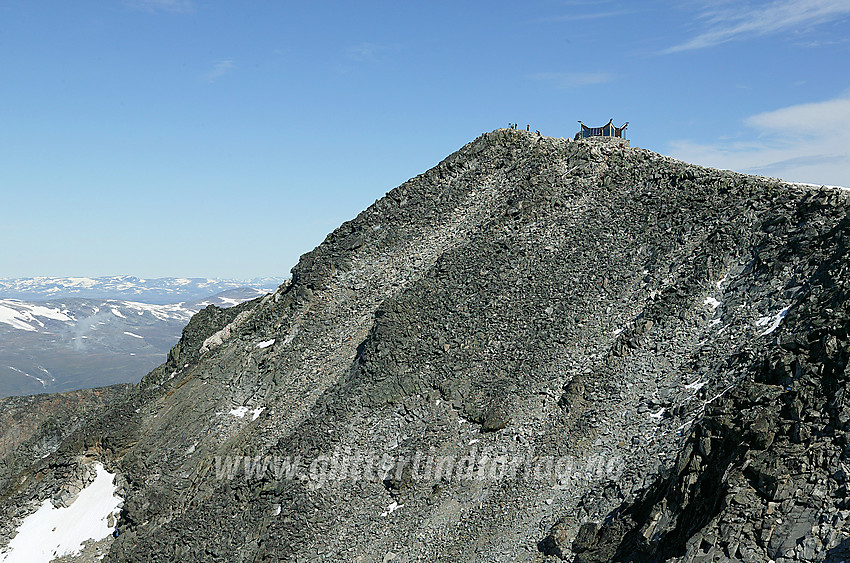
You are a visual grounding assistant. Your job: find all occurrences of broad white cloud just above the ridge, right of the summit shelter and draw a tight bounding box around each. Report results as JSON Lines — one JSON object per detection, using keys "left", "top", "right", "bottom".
{"left": 671, "top": 96, "right": 850, "bottom": 187}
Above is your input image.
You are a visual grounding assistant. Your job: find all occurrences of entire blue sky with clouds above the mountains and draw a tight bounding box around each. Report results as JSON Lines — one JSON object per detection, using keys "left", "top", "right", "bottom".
{"left": 0, "top": 0, "right": 850, "bottom": 278}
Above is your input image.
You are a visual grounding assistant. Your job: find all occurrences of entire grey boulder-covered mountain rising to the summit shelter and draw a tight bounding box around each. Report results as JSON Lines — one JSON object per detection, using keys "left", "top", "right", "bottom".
{"left": 0, "top": 130, "right": 850, "bottom": 562}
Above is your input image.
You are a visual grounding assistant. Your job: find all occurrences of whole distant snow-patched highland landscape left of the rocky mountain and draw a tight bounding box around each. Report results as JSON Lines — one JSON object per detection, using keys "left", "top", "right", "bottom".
{"left": 0, "top": 276, "right": 284, "bottom": 397}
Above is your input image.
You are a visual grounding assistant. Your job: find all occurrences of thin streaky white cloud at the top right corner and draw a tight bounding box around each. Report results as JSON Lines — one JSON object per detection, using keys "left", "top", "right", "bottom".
{"left": 662, "top": 0, "right": 850, "bottom": 54}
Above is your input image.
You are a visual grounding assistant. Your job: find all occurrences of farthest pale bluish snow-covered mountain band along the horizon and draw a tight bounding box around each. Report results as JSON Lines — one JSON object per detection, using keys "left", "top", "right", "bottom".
{"left": 0, "top": 276, "right": 285, "bottom": 304}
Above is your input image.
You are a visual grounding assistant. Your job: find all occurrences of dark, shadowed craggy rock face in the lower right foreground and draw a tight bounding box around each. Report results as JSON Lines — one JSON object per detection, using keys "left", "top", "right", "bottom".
{"left": 550, "top": 193, "right": 850, "bottom": 562}
